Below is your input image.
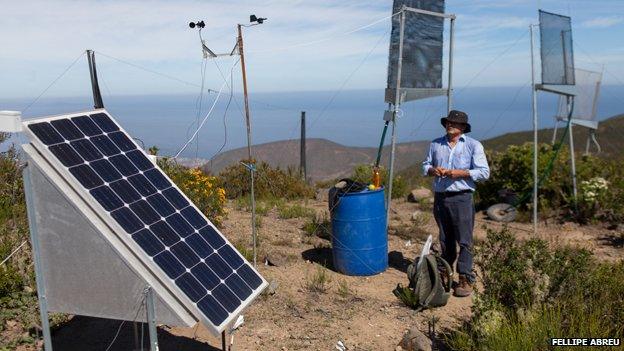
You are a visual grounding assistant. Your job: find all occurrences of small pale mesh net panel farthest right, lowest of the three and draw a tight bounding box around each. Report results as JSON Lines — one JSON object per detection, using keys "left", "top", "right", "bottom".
{"left": 557, "top": 68, "right": 602, "bottom": 127}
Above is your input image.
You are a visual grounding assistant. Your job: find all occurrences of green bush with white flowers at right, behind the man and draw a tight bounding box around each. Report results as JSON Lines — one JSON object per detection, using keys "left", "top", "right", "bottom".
{"left": 476, "top": 143, "right": 624, "bottom": 223}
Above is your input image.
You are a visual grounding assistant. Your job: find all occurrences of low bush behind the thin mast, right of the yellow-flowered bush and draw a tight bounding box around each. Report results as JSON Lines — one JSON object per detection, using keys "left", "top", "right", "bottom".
{"left": 219, "top": 160, "right": 315, "bottom": 200}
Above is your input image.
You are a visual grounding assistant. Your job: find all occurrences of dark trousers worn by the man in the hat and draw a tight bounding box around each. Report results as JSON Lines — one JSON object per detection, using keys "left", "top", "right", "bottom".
{"left": 433, "top": 192, "right": 475, "bottom": 282}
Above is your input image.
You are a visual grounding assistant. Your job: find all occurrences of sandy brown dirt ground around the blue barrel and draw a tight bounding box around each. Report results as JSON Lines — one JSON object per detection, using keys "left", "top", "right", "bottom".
{"left": 6, "top": 200, "right": 623, "bottom": 350}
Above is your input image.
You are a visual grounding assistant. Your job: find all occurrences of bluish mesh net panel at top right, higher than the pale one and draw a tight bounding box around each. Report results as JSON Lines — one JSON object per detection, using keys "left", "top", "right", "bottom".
{"left": 539, "top": 10, "right": 574, "bottom": 85}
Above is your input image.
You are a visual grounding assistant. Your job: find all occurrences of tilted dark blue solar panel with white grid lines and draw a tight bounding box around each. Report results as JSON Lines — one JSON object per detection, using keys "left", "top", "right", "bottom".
{"left": 27, "top": 110, "right": 267, "bottom": 332}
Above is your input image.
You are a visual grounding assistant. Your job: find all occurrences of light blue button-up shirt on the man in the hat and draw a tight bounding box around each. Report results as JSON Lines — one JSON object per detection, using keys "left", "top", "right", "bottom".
{"left": 423, "top": 134, "right": 490, "bottom": 192}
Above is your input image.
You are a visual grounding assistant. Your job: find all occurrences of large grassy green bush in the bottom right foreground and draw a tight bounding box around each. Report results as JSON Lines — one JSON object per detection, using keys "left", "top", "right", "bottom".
{"left": 445, "top": 229, "right": 624, "bottom": 350}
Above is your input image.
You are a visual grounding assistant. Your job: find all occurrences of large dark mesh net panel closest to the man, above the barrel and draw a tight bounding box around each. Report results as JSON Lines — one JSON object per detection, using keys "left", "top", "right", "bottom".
{"left": 388, "top": 0, "right": 444, "bottom": 89}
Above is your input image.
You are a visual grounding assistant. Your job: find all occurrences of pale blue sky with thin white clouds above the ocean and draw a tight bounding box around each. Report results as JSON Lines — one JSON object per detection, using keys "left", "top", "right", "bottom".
{"left": 0, "top": 0, "right": 624, "bottom": 99}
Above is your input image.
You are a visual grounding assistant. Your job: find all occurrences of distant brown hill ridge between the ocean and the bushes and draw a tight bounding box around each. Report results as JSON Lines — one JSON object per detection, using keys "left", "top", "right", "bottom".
{"left": 203, "top": 115, "right": 624, "bottom": 181}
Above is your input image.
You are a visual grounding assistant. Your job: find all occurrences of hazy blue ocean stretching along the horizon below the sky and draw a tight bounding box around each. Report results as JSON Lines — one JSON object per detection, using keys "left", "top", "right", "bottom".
{"left": 0, "top": 86, "right": 624, "bottom": 159}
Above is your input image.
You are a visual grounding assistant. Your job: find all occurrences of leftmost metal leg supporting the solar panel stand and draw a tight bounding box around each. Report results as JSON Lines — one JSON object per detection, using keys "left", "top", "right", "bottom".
{"left": 22, "top": 166, "right": 52, "bottom": 351}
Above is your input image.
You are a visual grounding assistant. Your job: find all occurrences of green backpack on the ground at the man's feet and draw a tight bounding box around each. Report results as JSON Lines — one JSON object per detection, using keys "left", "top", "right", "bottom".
{"left": 392, "top": 254, "right": 453, "bottom": 311}
